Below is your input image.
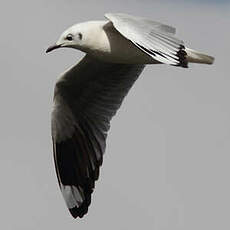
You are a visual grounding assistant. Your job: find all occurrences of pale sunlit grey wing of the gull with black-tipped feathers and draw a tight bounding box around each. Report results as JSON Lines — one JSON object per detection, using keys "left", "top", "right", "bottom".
{"left": 105, "top": 14, "right": 188, "bottom": 67}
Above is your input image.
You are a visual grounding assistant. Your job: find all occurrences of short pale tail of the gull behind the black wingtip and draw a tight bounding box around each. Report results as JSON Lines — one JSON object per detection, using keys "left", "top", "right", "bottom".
{"left": 185, "top": 47, "right": 214, "bottom": 64}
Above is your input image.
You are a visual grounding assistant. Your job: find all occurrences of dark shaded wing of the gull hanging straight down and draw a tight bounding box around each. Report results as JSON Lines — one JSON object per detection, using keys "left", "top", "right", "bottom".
{"left": 52, "top": 56, "right": 144, "bottom": 218}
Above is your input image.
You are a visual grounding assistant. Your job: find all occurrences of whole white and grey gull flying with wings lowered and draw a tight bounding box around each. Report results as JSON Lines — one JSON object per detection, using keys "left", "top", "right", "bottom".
{"left": 46, "top": 13, "right": 214, "bottom": 218}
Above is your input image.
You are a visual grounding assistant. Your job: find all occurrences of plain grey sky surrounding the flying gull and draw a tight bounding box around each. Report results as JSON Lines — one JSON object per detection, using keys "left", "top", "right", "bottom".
{"left": 0, "top": 0, "right": 230, "bottom": 230}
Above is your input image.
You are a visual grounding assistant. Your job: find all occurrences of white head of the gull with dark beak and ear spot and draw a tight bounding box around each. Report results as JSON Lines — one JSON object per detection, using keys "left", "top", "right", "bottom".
{"left": 46, "top": 22, "right": 95, "bottom": 53}
